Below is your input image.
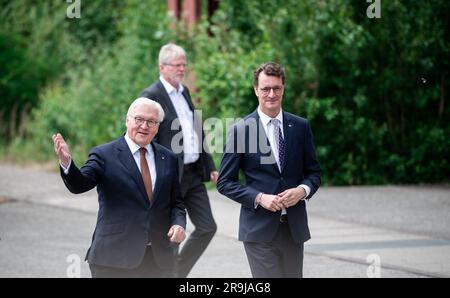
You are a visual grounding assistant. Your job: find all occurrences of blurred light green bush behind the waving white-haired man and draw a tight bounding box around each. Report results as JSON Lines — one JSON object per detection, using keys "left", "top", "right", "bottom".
{"left": 18, "top": 0, "right": 178, "bottom": 160}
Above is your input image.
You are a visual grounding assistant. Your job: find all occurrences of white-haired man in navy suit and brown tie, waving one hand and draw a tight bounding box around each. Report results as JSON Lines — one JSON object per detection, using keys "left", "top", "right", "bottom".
{"left": 53, "top": 98, "right": 186, "bottom": 277}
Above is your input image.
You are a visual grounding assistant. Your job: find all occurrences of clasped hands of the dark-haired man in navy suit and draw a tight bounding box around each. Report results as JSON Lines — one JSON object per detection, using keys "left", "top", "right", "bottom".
{"left": 259, "top": 187, "right": 306, "bottom": 212}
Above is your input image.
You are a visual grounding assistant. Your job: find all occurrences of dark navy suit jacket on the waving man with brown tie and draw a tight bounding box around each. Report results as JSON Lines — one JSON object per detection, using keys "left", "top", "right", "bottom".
{"left": 61, "top": 137, "right": 186, "bottom": 269}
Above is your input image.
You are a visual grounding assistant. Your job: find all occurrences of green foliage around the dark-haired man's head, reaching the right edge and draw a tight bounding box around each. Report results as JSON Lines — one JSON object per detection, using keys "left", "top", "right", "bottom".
{"left": 188, "top": 0, "right": 450, "bottom": 184}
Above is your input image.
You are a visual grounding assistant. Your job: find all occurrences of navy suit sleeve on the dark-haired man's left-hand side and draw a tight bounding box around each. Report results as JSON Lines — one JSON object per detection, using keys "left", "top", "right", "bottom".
{"left": 217, "top": 126, "right": 260, "bottom": 210}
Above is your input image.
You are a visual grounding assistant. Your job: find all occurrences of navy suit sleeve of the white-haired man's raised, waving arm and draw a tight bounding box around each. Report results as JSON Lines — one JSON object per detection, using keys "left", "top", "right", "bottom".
{"left": 60, "top": 149, "right": 104, "bottom": 194}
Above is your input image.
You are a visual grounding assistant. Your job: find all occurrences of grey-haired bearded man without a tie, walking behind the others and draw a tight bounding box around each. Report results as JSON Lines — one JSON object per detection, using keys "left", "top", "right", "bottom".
{"left": 140, "top": 44, "right": 218, "bottom": 277}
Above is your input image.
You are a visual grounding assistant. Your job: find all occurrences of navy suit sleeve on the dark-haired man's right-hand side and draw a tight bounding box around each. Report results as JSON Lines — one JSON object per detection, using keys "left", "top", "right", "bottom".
{"left": 302, "top": 122, "right": 321, "bottom": 199}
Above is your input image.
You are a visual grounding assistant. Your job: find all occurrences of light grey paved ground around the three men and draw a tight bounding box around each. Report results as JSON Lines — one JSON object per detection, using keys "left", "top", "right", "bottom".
{"left": 0, "top": 164, "right": 450, "bottom": 277}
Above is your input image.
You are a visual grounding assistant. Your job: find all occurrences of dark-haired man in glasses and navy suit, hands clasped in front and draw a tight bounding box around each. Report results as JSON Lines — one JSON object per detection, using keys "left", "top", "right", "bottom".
{"left": 217, "top": 62, "right": 320, "bottom": 278}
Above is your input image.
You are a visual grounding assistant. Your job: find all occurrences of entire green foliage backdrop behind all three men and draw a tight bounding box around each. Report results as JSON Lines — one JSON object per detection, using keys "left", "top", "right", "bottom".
{"left": 0, "top": 0, "right": 450, "bottom": 185}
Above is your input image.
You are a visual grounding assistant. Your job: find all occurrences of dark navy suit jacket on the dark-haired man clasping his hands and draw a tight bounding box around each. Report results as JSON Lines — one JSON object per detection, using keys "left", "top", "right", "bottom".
{"left": 217, "top": 111, "right": 320, "bottom": 243}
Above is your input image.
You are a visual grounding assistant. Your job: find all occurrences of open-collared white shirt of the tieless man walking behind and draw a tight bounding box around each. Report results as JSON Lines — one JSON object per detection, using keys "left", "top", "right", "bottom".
{"left": 159, "top": 76, "right": 200, "bottom": 164}
